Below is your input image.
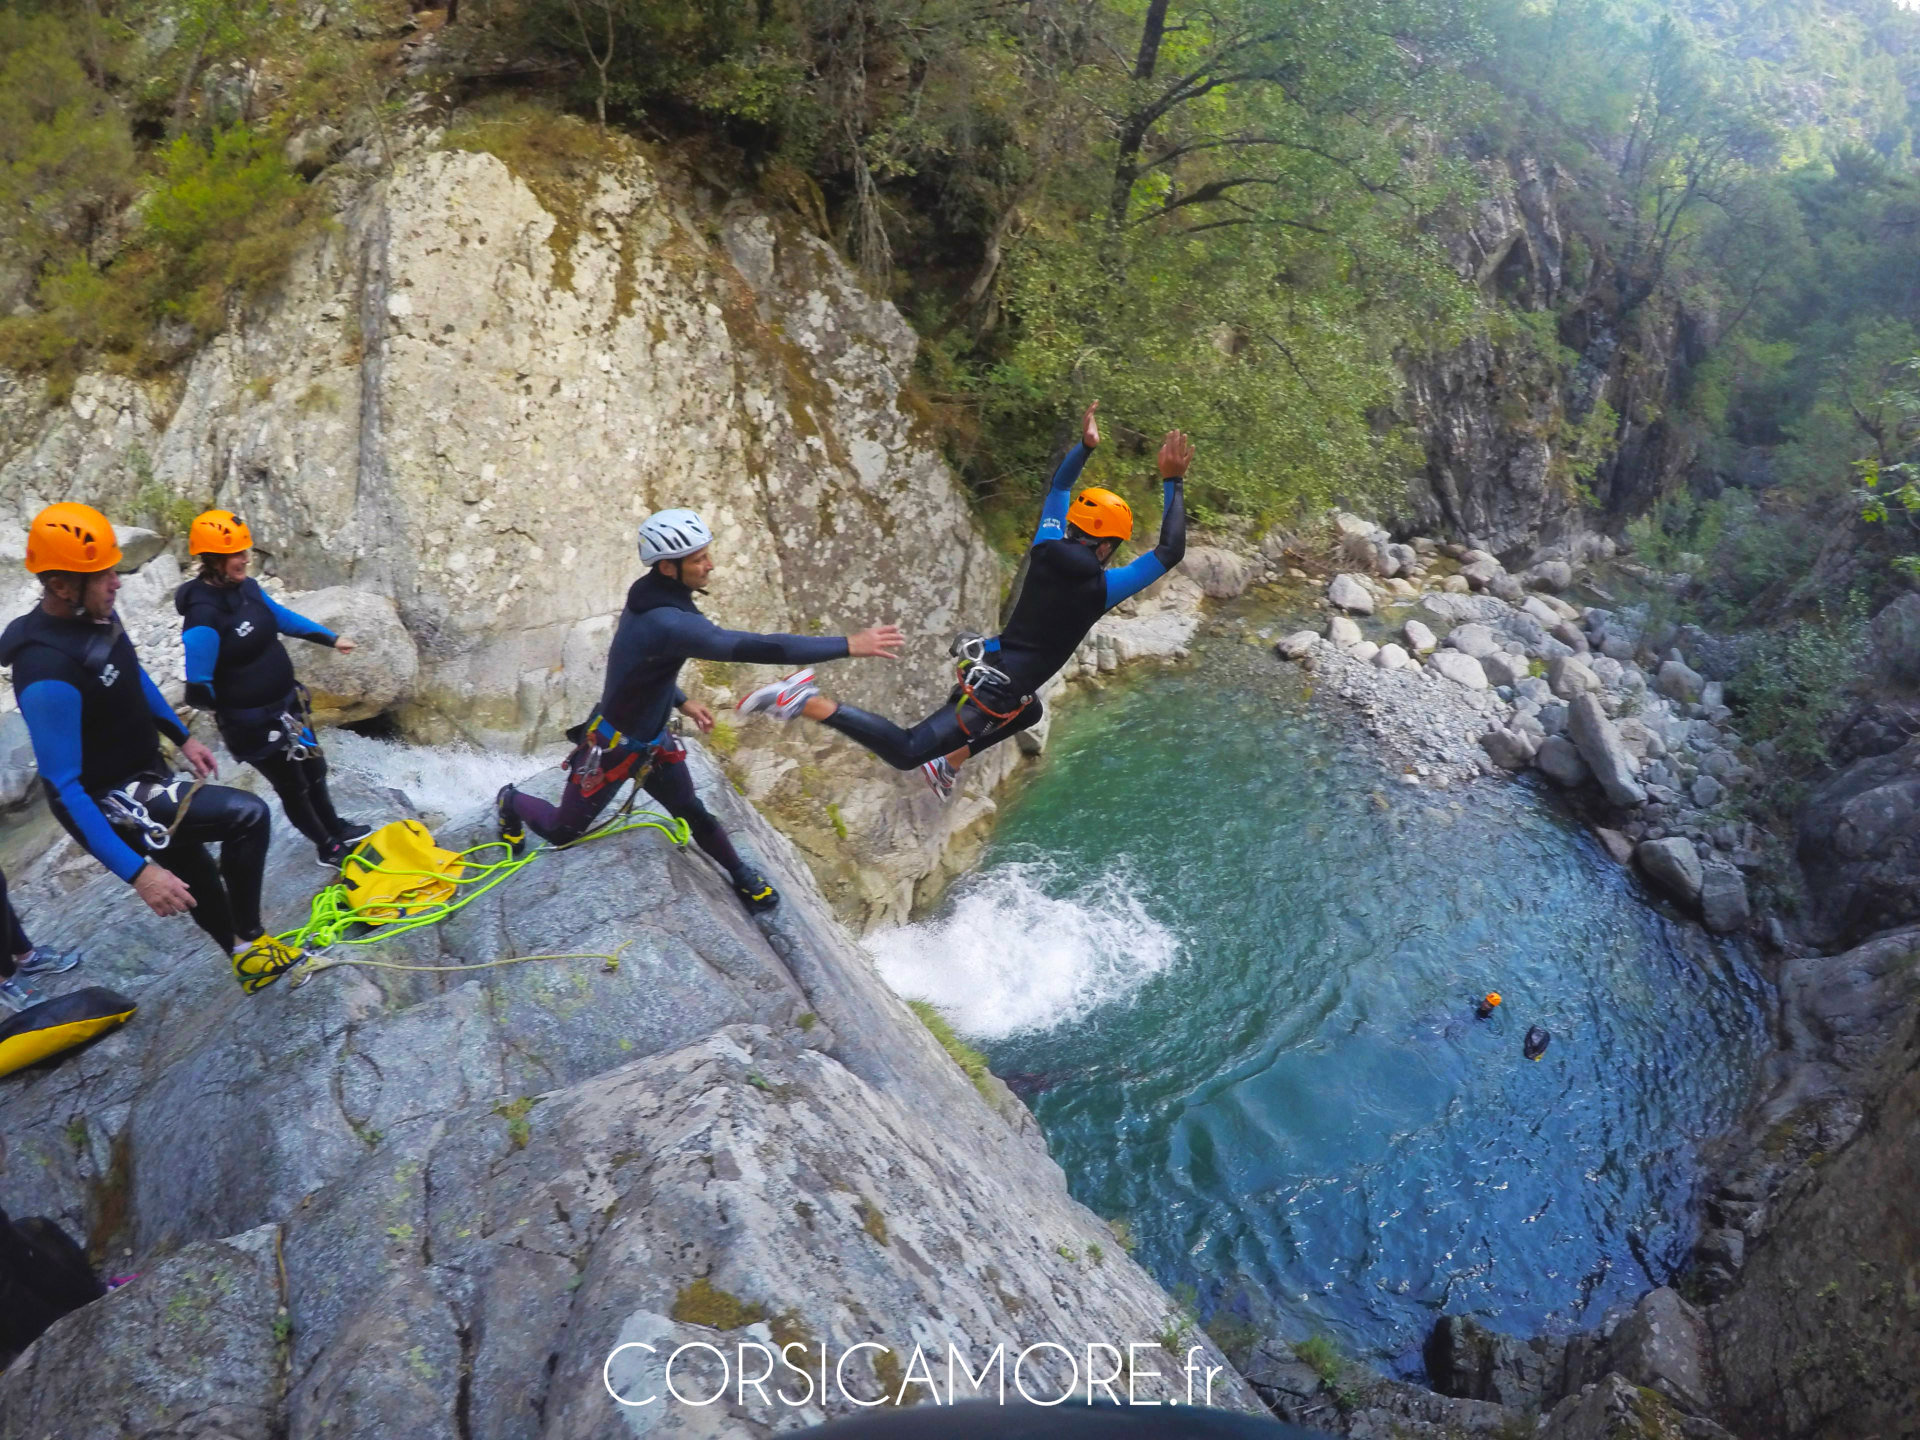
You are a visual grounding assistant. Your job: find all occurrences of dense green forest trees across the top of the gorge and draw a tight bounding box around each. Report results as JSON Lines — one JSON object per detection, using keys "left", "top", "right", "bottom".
{"left": 0, "top": 0, "right": 1920, "bottom": 564}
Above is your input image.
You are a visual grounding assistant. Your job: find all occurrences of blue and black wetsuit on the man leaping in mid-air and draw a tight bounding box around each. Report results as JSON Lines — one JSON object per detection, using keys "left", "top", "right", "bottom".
{"left": 824, "top": 445, "right": 1187, "bottom": 770}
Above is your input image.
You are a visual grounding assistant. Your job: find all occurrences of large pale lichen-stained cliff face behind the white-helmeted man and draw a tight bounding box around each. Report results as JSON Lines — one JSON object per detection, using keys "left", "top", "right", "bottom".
{"left": 0, "top": 136, "right": 1012, "bottom": 920}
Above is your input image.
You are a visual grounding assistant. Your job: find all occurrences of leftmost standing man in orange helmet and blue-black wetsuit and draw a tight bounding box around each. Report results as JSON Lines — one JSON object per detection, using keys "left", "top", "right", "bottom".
{"left": 0, "top": 503, "right": 301, "bottom": 995}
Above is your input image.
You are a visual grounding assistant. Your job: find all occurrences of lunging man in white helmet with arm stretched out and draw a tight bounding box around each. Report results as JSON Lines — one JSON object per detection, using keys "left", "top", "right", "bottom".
{"left": 495, "top": 511, "right": 902, "bottom": 910}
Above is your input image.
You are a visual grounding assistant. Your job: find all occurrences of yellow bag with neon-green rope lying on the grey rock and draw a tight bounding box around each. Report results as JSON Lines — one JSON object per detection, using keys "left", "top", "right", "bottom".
{"left": 278, "top": 783, "right": 693, "bottom": 985}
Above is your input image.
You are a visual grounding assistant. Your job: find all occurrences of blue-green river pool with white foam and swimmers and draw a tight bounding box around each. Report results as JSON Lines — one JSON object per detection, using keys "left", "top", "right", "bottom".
{"left": 872, "top": 639, "right": 1764, "bottom": 1371}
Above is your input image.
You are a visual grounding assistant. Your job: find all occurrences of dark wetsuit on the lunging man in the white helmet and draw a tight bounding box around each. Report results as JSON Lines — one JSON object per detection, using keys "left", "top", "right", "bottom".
{"left": 511, "top": 568, "right": 847, "bottom": 867}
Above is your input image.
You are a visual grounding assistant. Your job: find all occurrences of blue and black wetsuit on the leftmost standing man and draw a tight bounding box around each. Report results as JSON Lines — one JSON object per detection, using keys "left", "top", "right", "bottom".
{"left": 0, "top": 607, "right": 271, "bottom": 952}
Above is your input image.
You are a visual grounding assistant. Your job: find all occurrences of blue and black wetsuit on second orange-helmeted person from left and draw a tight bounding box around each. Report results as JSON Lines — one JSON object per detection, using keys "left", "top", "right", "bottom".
{"left": 173, "top": 576, "right": 365, "bottom": 852}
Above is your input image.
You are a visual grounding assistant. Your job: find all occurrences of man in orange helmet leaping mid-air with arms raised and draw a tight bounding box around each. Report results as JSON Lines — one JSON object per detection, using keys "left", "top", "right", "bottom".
{"left": 737, "top": 399, "right": 1194, "bottom": 801}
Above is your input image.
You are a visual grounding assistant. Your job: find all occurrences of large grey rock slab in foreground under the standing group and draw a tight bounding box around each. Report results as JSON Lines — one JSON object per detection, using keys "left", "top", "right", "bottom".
{"left": 0, "top": 753, "right": 1258, "bottom": 1440}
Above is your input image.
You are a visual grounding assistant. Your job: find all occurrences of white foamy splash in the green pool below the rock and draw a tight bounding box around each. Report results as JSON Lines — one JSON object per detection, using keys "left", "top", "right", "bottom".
{"left": 866, "top": 860, "right": 1181, "bottom": 1041}
